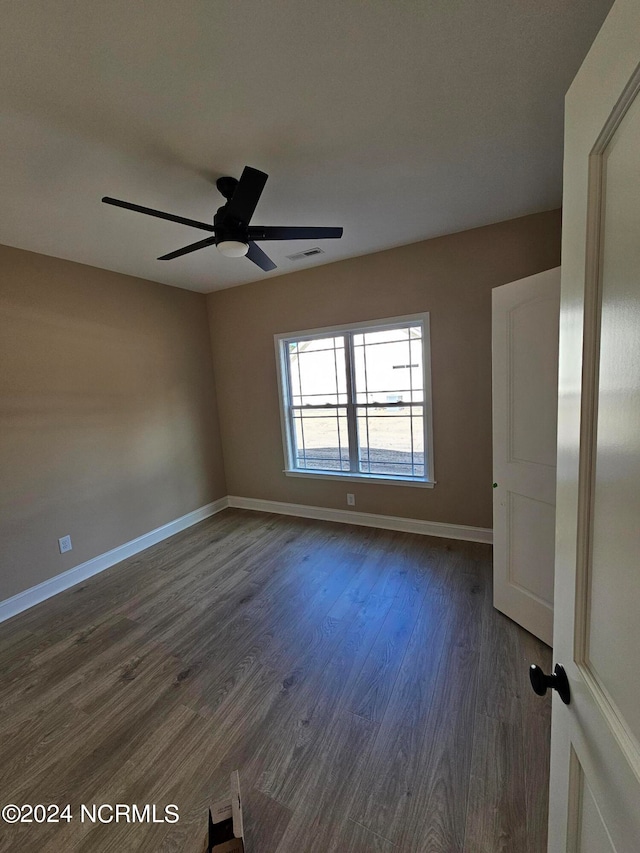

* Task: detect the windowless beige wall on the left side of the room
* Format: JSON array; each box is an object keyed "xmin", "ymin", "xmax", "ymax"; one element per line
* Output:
[{"xmin": 0, "ymin": 247, "xmax": 227, "ymax": 601}]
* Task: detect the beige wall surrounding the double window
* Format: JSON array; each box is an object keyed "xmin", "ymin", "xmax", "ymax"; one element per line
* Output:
[{"xmin": 208, "ymin": 211, "xmax": 560, "ymax": 527}]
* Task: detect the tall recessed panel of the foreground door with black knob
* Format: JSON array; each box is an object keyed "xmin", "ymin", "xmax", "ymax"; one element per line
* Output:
[{"xmin": 583, "ymin": 90, "xmax": 640, "ymax": 748}]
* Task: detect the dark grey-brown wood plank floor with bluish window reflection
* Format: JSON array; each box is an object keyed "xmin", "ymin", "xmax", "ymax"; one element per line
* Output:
[{"xmin": 0, "ymin": 510, "xmax": 551, "ymax": 853}]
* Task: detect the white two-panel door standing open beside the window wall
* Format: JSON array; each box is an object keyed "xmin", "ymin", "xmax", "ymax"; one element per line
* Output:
[{"xmin": 492, "ymin": 267, "xmax": 560, "ymax": 646}]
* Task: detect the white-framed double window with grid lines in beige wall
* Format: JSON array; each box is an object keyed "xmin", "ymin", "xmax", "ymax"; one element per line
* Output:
[{"xmin": 275, "ymin": 314, "xmax": 434, "ymax": 486}]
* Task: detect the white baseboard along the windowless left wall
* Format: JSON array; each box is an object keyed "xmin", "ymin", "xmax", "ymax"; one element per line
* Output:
[{"xmin": 0, "ymin": 497, "xmax": 229, "ymax": 622}]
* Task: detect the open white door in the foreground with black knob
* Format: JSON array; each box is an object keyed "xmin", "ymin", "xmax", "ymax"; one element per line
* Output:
[{"xmin": 549, "ymin": 0, "xmax": 640, "ymax": 853}]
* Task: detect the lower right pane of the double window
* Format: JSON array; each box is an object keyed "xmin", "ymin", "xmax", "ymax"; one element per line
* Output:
[{"xmin": 358, "ymin": 406, "xmax": 424, "ymax": 477}]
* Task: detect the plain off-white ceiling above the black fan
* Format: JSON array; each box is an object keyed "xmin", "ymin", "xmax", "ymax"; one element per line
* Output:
[{"xmin": 0, "ymin": 0, "xmax": 611, "ymax": 292}]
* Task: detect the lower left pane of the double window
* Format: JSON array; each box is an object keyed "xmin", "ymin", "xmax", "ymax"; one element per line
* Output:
[{"xmin": 293, "ymin": 408, "xmax": 349, "ymax": 471}]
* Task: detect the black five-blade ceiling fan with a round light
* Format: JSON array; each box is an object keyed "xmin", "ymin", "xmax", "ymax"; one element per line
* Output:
[{"xmin": 102, "ymin": 166, "xmax": 342, "ymax": 272}]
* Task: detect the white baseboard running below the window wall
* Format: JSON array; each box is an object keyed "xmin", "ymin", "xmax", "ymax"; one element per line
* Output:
[{"xmin": 229, "ymin": 495, "xmax": 493, "ymax": 544}]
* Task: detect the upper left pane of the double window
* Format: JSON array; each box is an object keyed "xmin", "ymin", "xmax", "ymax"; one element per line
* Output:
[{"xmin": 289, "ymin": 337, "xmax": 347, "ymax": 406}]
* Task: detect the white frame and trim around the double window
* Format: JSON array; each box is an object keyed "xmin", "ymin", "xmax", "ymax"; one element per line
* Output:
[{"xmin": 273, "ymin": 312, "xmax": 436, "ymax": 488}]
